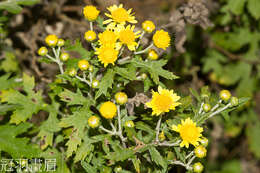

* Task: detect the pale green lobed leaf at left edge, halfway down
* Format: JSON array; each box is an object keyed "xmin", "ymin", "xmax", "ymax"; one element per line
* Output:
[{"xmin": 1, "ymin": 74, "xmax": 44, "ymax": 124}]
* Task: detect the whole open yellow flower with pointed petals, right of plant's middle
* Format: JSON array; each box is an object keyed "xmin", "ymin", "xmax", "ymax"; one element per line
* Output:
[{"xmin": 146, "ymin": 86, "xmax": 181, "ymax": 116}]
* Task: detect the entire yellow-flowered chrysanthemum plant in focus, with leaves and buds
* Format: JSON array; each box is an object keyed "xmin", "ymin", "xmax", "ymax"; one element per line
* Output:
[{"xmin": 1, "ymin": 5, "xmax": 250, "ymax": 173}]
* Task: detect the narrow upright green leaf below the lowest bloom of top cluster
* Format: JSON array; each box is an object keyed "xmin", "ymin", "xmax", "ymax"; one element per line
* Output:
[{"xmin": 95, "ymin": 69, "xmax": 115, "ymax": 99}]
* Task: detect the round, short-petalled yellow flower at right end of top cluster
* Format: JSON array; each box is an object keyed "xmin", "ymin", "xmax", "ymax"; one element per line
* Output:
[{"xmin": 153, "ymin": 30, "xmax": 171, "ymax": 50}]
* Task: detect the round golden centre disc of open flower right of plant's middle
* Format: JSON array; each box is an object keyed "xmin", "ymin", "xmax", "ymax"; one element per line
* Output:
[{"xmin": 154, "ymin": 94, "xmax": 172, "ymax": 112}]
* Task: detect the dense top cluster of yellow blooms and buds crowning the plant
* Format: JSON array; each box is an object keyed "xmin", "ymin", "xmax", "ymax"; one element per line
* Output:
[{"xmin": 83, "ymin": 4, "xmax": 171, "ymax": 67}]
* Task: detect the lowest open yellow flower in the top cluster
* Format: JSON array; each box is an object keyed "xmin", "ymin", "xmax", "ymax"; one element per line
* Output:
[{"xmin": 95, "ymin": 46, "xmax": 118, "ymax": 67}]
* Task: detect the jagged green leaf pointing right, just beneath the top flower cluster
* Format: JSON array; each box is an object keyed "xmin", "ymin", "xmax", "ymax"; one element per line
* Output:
[{"xmin": 131, "ymin": 58, "xmax": 178, "ymax": 85}]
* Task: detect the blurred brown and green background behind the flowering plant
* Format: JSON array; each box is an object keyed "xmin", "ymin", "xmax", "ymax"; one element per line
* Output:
[{"xmin": 0, "ymin": 0, "xmax": 260, "ymax": 173}]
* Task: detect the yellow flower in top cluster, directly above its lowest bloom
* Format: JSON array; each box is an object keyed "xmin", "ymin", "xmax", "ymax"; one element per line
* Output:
[{"xmin": 98, "ymin": 30, "xmax": 117, "ymax": 46}]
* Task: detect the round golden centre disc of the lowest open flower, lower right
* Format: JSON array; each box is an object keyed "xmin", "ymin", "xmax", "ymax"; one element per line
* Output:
[{"xmin": 180, "ymin": 124, "xmax": 200, "ymax": 142}]
